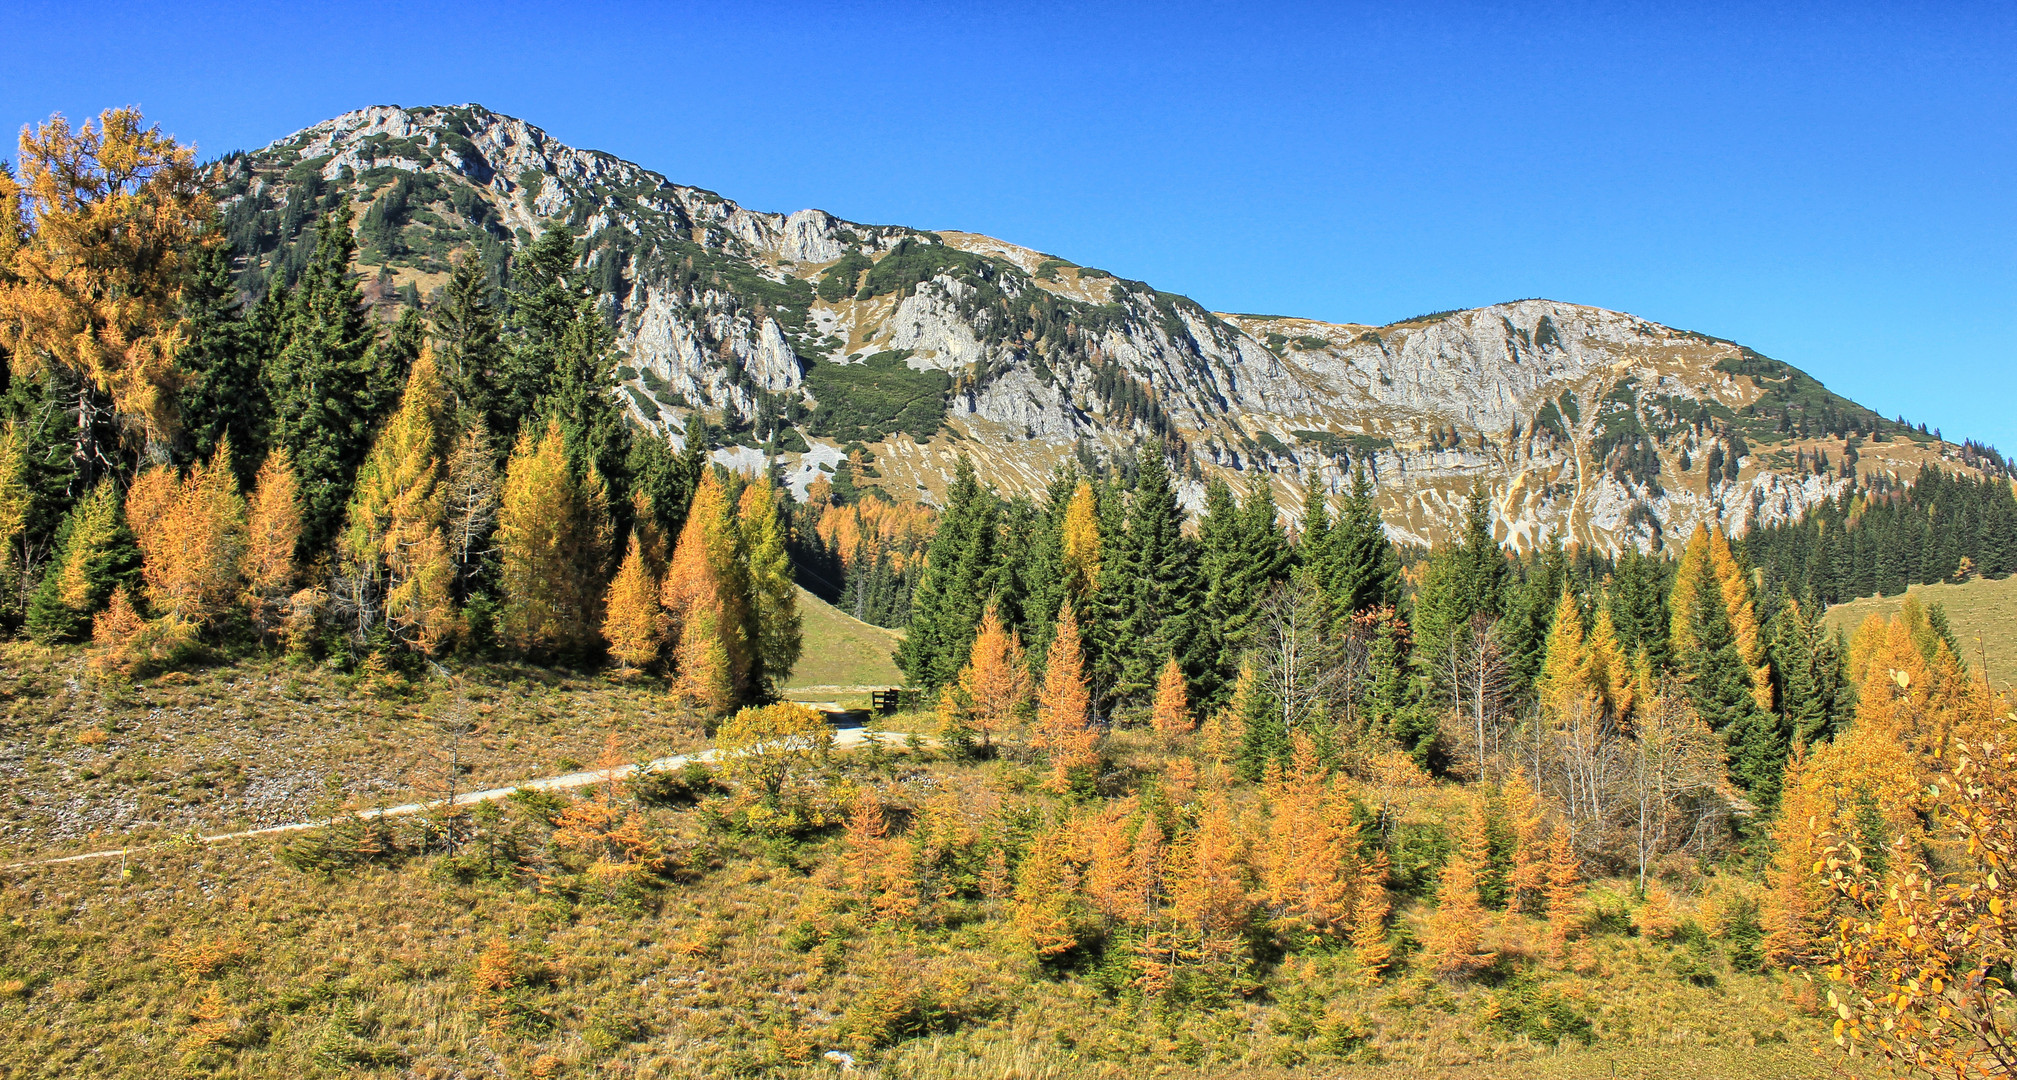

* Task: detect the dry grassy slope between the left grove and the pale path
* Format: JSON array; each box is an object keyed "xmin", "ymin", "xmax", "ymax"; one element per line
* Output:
[{"xmin": 0, "ymin": 642, "xmax": 704, "ymax": 862}]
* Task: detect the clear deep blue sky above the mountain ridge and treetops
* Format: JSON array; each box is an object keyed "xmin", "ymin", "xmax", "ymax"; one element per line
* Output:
[{"xmin": 0, "ymin": 0, "xmax": 2017, "ymax": 452}]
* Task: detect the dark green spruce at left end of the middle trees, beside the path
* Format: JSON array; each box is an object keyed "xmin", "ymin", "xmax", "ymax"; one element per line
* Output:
[{"xmin": 896, "ymin": 454, "xmax": 1000, "ymax": 688}]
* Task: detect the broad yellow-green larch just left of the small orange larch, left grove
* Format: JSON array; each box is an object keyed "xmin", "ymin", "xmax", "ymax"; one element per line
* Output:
[{"xmin": 496, "ymin": 420, "xmax": 609, "ymax": 656}]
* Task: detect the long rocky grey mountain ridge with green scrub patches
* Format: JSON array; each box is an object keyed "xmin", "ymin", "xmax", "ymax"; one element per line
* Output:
[{"xmin": 222, "ymin": 105, "xmax": 2003, "ymax": 549}]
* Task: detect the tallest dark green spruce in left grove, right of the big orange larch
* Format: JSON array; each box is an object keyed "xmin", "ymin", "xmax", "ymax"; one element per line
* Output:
[{"xmin": 264, "ymin": 210, "xmax": 371, "ymax": 551}]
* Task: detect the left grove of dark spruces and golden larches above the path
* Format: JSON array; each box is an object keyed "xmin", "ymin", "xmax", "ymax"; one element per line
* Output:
[{"xmin": 0, "ymin": 109, "xmax": 799, "ymax": 711}]
